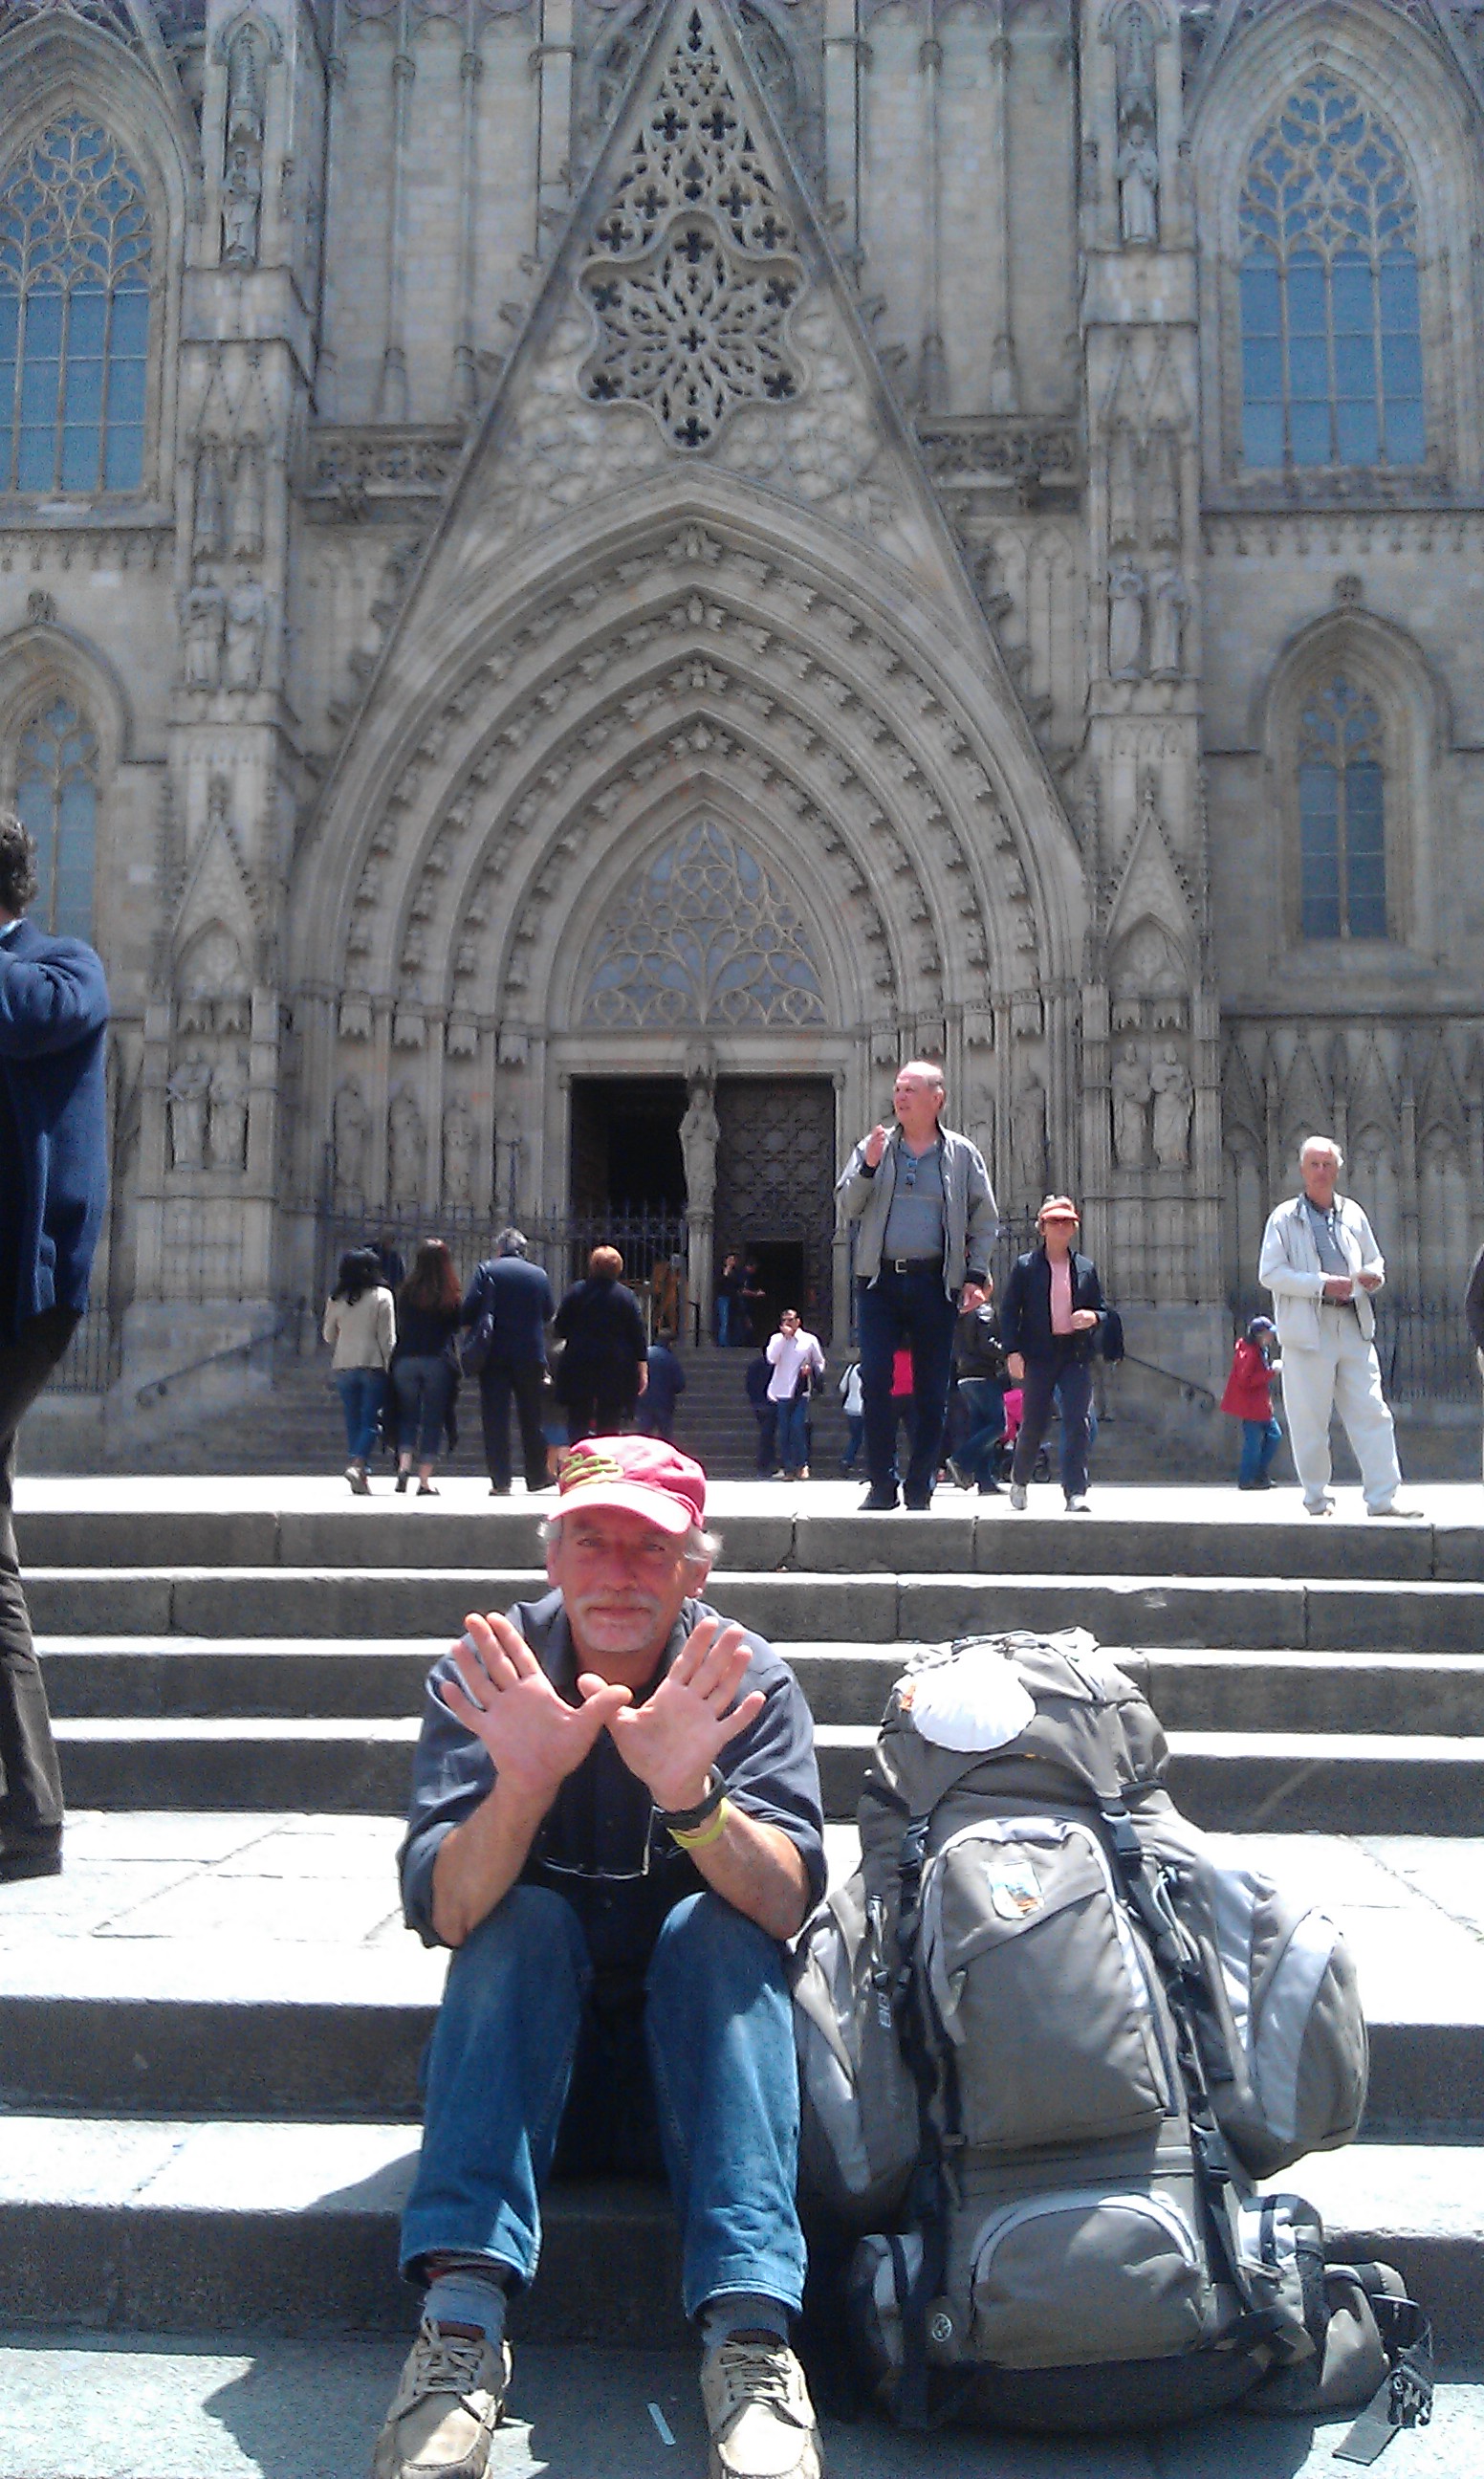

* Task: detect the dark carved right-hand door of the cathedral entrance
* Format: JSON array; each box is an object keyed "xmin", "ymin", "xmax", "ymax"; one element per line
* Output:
[{"xmin": 716, "ymin": 1076, "xmax": 835, "ymax": 1341}]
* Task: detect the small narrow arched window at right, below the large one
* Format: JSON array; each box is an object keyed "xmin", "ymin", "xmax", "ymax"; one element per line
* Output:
[{"xmin": 1298, "ymin": 671, "xmax": 1387, "ymax": 937}]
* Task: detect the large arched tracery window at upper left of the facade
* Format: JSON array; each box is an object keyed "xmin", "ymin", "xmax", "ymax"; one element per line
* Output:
[{"xmin": 0, "ymin": 112, "xmax": 148, "ymax": 491}]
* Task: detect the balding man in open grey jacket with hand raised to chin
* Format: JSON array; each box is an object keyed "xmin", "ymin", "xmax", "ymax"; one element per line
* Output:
[{"xmin": 835, "ymin": 1059, "xmax": 998, "ymax": 1512}]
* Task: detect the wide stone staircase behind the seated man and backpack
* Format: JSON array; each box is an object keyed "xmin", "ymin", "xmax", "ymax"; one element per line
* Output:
[{"xmin": 0, "ymin": 1477, "xmax": 1484, "ymax": 2360}]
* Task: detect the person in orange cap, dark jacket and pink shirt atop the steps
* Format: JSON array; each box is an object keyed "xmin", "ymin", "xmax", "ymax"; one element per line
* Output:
[{"xmin": 1001, "ymin": 1197, "xmax": 1107, "ymax": 1515}]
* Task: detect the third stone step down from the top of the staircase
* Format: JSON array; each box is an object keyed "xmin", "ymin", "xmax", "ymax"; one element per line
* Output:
[{"xmin": 39, "ymin": 1636, "xmax": 1484, "ymax": 1738}]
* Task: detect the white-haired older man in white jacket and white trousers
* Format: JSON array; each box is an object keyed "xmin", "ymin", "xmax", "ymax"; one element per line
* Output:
[{"xmin": 1258, "ymin": 1135, "xmax": 1422, "ymax": 1515}]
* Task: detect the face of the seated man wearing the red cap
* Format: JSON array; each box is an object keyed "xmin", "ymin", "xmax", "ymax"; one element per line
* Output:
[{"xmin": 545, "ymin": 1507, "xmax": 704, "ymax": 1686}]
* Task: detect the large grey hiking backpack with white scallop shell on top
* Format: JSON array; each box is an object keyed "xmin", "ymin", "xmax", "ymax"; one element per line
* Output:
[{"xmin": 796, "ymin": 1632, "xmax": 1420, "ymax": 2427}]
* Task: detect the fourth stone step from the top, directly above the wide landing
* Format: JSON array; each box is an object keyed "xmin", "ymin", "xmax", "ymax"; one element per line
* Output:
[{"xmin": 57, "ymin": 1716, "xmax": 1484, "ymax": 1834}]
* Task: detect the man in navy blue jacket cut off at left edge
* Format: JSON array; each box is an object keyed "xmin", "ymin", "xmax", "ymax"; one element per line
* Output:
[{"xmin": 0, "ymin": 816, "xmax": 109, "ymax": 1884}]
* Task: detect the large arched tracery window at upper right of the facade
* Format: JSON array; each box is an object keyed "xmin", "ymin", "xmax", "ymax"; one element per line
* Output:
[{"xmin": 1238, "ymin": 70, "xmax": 1427, "ymax": 469}]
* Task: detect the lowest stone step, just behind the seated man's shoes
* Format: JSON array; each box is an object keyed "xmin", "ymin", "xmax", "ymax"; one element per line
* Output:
[{"xmin": 0, "ymin": 2115, "xmax": 1484, "ymax": 2360}]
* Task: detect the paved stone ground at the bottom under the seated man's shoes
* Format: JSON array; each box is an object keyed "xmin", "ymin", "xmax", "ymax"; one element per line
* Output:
[{"xmin": 0, "ymin": 2336, "xmax": 1484, "ymax": 2479}]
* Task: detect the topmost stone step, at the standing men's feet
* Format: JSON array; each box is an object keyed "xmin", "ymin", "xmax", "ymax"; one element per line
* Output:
[{"xmin": 17, "ymin": 1480, "xmax": 1484, "ymax": 1584}]
